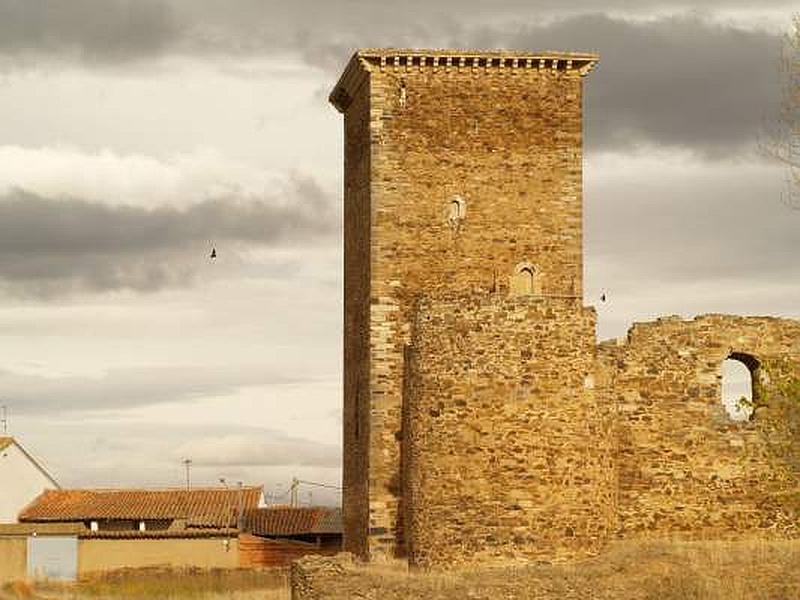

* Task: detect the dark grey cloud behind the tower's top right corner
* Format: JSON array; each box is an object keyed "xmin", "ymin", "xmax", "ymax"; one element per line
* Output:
[{"xmin": 496, "ymin": 15, "xmax": 781, "ymax": 156}]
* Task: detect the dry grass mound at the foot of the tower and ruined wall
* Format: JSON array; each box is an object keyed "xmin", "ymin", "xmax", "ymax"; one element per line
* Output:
[{"xmin": 306, "ymin": 541, "xmax": 800, "ymax": 600}]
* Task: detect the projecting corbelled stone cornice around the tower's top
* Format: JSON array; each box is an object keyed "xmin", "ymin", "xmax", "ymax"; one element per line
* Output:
[{"xmin": 328, "ymin": 48, "xmax": 600, "ymax": 113}]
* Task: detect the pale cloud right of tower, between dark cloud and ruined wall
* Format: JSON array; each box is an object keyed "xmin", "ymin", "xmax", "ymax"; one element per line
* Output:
[{"xmin": 585, "ymin": 158, "xmax": 800, "ymax": 337}]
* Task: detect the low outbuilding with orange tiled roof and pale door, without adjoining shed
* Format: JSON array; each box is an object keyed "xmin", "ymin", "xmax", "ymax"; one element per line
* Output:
[{"xmin": 0, "ymin": 487, "xmax": 263, "ymax": 580}]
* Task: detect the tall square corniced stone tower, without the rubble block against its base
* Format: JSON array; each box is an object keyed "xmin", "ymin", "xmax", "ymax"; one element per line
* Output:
[{"xmin": 330, "ymin": 50, "xmax": 597, "ymax": 557}]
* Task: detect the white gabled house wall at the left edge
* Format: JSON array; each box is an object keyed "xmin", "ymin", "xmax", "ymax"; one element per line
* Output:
[{"xmin": 0, "ymin": 437, "xmax": 60, "ymax": 523}]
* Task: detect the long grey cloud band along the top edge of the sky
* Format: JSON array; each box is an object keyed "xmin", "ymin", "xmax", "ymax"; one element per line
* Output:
[{"xmin": 0, "ymin": 0, "xmax": 794, "ymax": 63}]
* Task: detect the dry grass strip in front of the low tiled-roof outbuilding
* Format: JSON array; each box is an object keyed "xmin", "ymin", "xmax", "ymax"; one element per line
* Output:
[{"xmin": 0, "ymin": 569, "xmax": 291, "ymax": 600}]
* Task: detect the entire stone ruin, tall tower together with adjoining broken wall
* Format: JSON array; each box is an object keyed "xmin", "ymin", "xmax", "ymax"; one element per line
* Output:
[{"xmin": 331, "ymin": 50, "xmax": 800, "ymax": 566}]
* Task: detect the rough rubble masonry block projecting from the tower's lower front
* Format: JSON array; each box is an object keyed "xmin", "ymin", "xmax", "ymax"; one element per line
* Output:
[{"xmin": 406, "ymin": 295, "xmax": 615, "ymax": 567}]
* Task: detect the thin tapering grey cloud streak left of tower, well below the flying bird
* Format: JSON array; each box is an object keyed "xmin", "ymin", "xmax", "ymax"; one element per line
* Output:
[{"xmin": 0, "ymin": 365, "xmax": 308, "ymax": 416}]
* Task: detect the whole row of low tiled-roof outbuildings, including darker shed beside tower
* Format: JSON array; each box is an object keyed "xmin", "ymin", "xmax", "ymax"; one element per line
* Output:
[{"xmin": 0, "ymin": 487, "xmax": 341, "ymax": 582}]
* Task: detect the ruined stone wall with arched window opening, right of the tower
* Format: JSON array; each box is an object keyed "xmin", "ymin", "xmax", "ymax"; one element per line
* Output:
[{"xmin": 598, "ymin": 315, "xmax": 800, "ymax": 539}]
